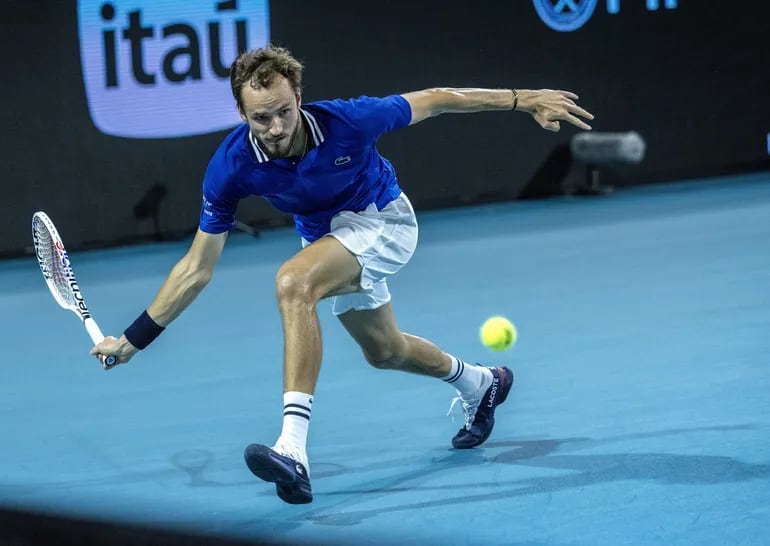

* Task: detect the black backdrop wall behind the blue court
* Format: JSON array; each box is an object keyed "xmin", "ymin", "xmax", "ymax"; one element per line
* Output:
[{"xmin": 0, "ymin": 0, "xmax": 770, "ymax": 255}]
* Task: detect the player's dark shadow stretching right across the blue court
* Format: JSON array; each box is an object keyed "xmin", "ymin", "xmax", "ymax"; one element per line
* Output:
[{"xmin": 305, "ymin": 427, "xmax": 770, "ymax": 525}]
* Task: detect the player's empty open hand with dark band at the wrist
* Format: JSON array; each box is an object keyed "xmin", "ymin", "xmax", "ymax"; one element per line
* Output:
[{"xmin": 516, "ymin": 89, "xmax": 594, "ymax": 131}]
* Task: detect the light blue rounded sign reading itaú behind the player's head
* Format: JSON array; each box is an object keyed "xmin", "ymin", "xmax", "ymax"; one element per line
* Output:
[{"xmin": 78, "ymin": 0, "xmax": 270, "ymax": 138}]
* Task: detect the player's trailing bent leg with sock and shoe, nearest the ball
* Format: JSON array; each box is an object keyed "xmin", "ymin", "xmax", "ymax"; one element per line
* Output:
[{"xmin": 338, "ymin": 303, "xmax": 513, "ymax": 449}]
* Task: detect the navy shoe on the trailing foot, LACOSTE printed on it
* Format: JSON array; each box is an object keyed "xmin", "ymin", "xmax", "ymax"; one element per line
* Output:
[{"xmin": 449, "ymin": 367, "xmax": 513, "ymax": 449}]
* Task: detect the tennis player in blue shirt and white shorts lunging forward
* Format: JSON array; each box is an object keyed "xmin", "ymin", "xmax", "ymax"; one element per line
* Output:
[{"xmin": 91, "ymin": 46, "xmax": 593, "ymax": 504}]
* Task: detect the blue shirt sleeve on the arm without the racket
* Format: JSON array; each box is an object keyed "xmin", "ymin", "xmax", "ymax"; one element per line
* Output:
[{"xmin": 332, "ymin": 95, "xmax": 412, "ymax": 140}]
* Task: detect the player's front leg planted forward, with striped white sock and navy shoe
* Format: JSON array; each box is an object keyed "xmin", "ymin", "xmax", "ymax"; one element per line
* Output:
[{"xmin": 244, "ymin": 237, "xmax": 361, "ymax": 504}]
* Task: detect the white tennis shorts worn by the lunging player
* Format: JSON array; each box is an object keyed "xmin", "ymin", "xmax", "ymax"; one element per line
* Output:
[{"xmin": 302, "ymin": 192, "xmax": 418, "ymax": 315}]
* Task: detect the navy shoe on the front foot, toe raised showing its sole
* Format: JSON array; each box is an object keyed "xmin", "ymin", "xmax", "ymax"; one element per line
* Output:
[{"xmin": 243, "ymin": 444, "xmax": 313, "ymax": 504}]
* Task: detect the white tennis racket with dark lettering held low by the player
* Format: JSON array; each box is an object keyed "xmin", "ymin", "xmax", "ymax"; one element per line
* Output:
[{"xmin": 32, "ymin": 211, "xmax": 117, "ymax": 367}]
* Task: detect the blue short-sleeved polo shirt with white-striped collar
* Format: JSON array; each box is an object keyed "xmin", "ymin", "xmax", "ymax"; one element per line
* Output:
[{"xmin": 200, "ymin": 95, "xmax": 412, "ymax": 242}]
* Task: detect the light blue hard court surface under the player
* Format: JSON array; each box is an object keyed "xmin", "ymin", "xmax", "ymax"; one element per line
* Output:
[{"xmin": 0, "ymin": 173, "xmax": 770, "ymax": 545}]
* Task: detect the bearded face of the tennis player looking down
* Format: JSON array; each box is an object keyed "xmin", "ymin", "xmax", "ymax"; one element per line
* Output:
[{"xmin": 240, "ymin": 76, "xmax": 301, "ymax": 158}]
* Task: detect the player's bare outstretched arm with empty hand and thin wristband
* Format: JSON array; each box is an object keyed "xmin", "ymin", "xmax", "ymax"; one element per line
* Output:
[{"xmin": 402, "ymin": 87, "xmax": 594, "ymax": 131}]
